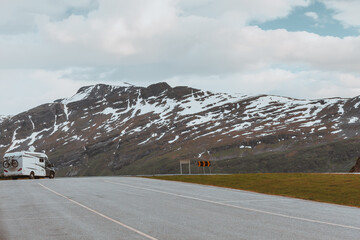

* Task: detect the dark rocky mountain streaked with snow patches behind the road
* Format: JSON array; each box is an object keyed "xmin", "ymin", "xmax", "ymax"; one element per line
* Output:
[{"xmin": 0, "ymin": 83, "xmax": 360, "ymax": 176}]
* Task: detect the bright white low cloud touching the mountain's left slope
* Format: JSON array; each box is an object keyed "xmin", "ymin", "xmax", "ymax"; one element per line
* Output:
[{"xmin": 0, "ymin": 69, "xmax": 92, "ymax": 115}]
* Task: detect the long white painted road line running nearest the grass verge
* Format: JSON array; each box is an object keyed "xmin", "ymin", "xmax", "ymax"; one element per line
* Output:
[{"xmin": 104, "ymin": 180, "xmax": 360, "ymax": 230}]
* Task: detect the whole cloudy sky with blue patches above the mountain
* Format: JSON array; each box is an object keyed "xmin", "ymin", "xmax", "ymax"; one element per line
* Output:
[{"xmin": 0, "ymin": 0, "xmax": 360, "ymax": 115}]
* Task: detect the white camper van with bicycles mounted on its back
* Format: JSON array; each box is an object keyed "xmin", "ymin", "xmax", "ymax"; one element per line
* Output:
[{"xmin": 3, "ymin": 152, "xmax": 55, "ymax": 179}]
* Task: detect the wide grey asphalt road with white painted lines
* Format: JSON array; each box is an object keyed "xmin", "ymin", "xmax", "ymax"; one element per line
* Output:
[{"xmin": 0, "ymin": 177, "xmax": 360, "ymax": 240}]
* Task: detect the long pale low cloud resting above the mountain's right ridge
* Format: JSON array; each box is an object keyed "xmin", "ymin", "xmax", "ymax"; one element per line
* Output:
[{"xmin": 166, "ymin": 68, "xmax": 360, "ymax": 99}]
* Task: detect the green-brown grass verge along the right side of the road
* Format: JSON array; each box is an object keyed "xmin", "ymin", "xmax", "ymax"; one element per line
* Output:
[{"xmin": 151, "ymin": 173, "xmax": 360, "ymax": 207}]
